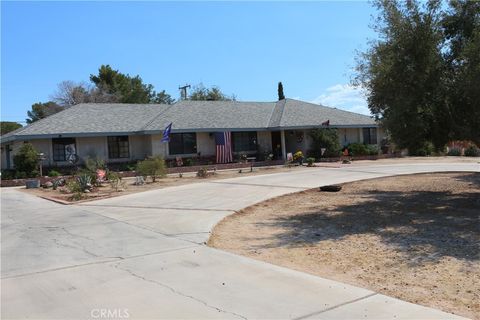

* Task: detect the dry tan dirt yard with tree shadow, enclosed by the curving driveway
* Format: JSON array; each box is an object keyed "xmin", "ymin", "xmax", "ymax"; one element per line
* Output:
[{"xmin": 209, "ymin": 173, "xmax": 480, "ymax": 319}]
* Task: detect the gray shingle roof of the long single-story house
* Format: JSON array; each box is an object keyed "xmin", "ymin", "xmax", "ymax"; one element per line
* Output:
[{"xmin": 1, "ymin": 99, "xmax": 376, "ymax": 142}]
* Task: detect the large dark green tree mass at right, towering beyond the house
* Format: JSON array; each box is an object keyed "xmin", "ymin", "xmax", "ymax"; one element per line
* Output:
[{"xmin": 353, "ymin": 0, "xmax": 480, "ymax": 153}]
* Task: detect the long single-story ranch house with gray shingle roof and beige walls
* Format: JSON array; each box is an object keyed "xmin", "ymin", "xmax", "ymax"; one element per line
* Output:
[{"xmin": 1, "ymin": 99, "xmax": 383, "ymax": 169}]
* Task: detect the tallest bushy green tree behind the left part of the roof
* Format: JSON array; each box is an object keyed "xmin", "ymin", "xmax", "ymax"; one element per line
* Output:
[{"xmin": 90, "ymin": 65, "xmax": 174, "ymax": 104}]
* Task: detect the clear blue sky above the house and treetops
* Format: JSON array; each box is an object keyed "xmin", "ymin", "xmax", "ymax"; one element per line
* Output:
[{"xmin": 1, "ymin": 1, "xmax": 375, "ymax": 121}]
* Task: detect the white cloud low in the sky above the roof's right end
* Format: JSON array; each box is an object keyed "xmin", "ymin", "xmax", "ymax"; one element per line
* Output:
[{"xmin": 312, "ymin": 84, "xmax": 370, "ymax": 115}]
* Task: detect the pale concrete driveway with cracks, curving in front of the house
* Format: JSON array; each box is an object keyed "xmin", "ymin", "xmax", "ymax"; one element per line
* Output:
[{"xmin": 1, "ymin": 160, "xmax": 480, "ymax": 319}]
